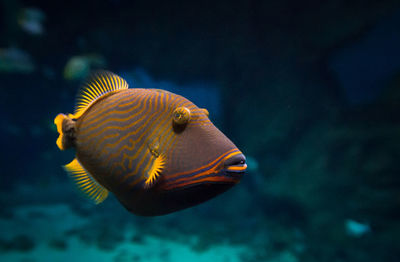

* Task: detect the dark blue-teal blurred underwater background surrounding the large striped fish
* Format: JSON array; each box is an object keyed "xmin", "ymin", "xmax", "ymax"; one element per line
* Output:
[{"xmin": 0, "ymin": 0, "xmax": 400, "ymax": 262}]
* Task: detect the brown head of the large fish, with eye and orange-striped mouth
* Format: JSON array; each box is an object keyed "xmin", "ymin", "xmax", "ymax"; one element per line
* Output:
[{"xmin": 157, "ymin": 98, "xmax": 247, "ymax": 192}]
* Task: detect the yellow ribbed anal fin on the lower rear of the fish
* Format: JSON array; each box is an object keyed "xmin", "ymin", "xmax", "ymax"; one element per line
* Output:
[{"xmin": 64, "ymin": 158, "xmax": 108, "ymax": 204}]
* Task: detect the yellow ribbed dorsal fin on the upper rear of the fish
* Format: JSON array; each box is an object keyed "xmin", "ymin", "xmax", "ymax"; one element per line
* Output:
[{"xmin": 68, "ymin": 71, "xmax": 128, "ymax": 119}]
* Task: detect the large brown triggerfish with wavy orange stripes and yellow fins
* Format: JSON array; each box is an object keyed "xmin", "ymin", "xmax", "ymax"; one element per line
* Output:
[{"xmin": 54, "ymin": 71, "xmax": 247, "ymax": 216}]
